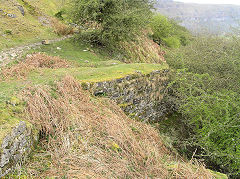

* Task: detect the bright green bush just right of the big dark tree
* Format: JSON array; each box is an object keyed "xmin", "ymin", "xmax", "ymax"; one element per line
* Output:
[{"xmin": 150, "ymin": 14, "xmax": 191, "ymax": 48}]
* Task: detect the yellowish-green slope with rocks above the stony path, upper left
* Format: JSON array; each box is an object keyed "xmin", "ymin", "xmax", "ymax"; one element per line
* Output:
[{"xmin": 0, "ymin": 0, "xmax": 61, "ymax": 50}]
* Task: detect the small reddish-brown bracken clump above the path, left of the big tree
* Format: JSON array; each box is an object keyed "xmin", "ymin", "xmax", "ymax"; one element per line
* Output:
[{"xmin": 51, "ymin": 18, "xmax": 74, "ymax": 35}]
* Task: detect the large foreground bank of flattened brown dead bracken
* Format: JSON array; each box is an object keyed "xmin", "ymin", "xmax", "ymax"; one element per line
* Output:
[{"xmin": 19, "ymin": 76, "xmax": 211, "ymax": 178}]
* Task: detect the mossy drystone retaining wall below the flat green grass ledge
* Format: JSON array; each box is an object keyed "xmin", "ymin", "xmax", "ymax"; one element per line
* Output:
[{"xmin": 83, "ymin": 70, "xmax": 169, "ymax": 122}]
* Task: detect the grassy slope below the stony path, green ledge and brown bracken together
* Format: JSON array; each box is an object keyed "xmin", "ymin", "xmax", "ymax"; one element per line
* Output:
[{"xmin": 0, "ymin": 34, "xmax": 229, "ymax": 178}]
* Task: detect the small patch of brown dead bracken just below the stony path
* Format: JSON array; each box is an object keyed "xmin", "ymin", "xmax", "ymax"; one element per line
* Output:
[{"xmin": 1, "ymin": 53, "xmax": 71, "ymax": 79}]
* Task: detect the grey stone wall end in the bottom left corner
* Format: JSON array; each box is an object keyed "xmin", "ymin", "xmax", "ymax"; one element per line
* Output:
[{"xmin": 0, "ymin": 121, "xmax": 37, "ymax": 178}]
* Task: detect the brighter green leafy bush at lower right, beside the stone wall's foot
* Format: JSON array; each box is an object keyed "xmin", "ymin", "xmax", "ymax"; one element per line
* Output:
[{"xmin": 171, "ymin": 70, "xmax": 240, "ymax": 176}]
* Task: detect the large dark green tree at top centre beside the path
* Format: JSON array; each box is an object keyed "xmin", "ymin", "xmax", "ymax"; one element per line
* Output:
[{"xmin": 70, "ymin": 0, "xmax": 152, "ymax": 45}]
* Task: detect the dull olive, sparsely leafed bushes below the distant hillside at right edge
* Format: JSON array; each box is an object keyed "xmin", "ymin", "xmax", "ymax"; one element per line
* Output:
[{"xmin": 166, "ymin": 37, "xmax": 240, "ymax": 92}]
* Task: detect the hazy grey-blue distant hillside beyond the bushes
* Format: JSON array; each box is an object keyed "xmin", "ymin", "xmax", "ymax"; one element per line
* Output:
[{"xmin": 156, "ymin": 0, "xmax": 240, "ymax": 34}]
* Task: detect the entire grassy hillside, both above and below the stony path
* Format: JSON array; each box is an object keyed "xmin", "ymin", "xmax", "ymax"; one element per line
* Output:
[{"xmin": 0, "ymin": 0, "xmax": 230, "ymax": 178}]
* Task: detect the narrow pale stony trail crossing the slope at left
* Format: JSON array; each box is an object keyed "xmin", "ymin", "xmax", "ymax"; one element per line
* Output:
[{"xmin": 0, "ymin": 35, "xmax": 72, "ymax": 67}]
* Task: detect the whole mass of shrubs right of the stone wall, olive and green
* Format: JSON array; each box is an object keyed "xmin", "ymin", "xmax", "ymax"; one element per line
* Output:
[{"xmin": 167, "ymin": 37, "xmax": 240, "ymax": 177}]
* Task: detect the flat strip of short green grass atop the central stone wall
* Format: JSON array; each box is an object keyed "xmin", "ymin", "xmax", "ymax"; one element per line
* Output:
[{"xmin": 29, "ymin": 63, "xmax": 168, "ymax": 83}]
